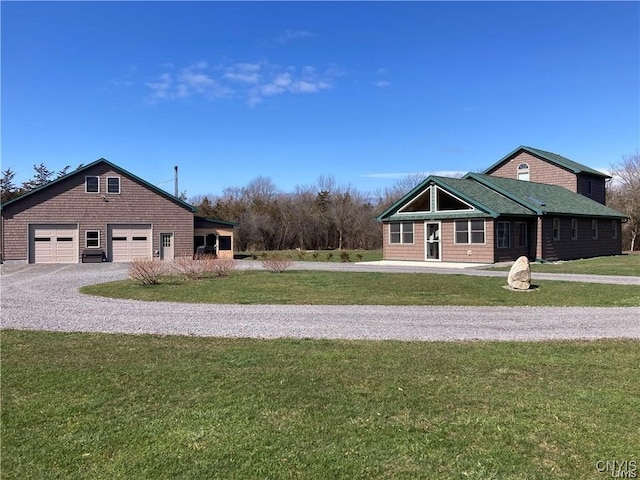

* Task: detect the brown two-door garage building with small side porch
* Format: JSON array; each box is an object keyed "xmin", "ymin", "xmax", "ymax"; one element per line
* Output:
[{"xmin": 0, "ymin": 158, "xmax": 235, "ymax": 263}]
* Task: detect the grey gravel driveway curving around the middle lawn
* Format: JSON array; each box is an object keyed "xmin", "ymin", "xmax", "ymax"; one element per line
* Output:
[{"xmin": 0, "ymin": 262, "xmax": 640, "ymax": 341}]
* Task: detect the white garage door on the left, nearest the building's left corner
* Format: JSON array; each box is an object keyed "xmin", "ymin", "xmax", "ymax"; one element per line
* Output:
[{"xmin": 29, "ymin": 224, "xmax": 78, "ymax": 263}]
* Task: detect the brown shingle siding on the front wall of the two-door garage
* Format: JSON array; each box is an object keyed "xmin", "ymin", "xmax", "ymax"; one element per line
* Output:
[{"xmin": 2, "ymin": 163, "xmax": 193, "ymax": 261}]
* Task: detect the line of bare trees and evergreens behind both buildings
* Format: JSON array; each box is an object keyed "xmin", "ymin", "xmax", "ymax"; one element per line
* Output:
[{"xmin": 0, "ymin": 152, "xmax": 640, "ymax": 251}]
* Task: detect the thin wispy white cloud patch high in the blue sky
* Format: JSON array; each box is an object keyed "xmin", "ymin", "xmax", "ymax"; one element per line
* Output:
[{"xmin": 146, "ymin": 61, "xmax": 344, "ymax": 106}]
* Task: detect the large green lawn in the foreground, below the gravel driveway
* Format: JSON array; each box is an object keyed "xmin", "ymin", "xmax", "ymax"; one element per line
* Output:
[{"xmin": 1, "ymin": 330, "xmax": 640, "ymax": 480}]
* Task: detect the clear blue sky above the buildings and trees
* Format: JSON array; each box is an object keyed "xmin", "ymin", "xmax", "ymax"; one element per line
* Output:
[{"xmin": 0, "ymin": 1, "xmax": 640, "ymax": 197}]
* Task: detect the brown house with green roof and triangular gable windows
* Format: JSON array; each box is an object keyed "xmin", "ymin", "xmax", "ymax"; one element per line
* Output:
[{"xmin": 377, "ymin": 147, "xmax": 625, "ymax": 263}]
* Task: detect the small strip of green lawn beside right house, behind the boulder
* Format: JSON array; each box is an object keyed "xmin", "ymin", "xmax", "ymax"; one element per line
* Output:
[{"xmin": 494, "ymin": 252, "xmax": 640, "ymax": 277}]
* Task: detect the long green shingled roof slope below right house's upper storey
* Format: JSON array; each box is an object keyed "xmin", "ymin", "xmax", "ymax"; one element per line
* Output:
[{"xmin": 464, "ymin": 173, "xmax": 626, "ymax": 218}]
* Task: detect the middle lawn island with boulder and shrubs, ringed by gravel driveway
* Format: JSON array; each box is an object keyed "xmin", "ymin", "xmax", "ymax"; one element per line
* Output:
[{"xmin": 80, "ymin": 270, "xmax": 640, "ymax": 307}]
